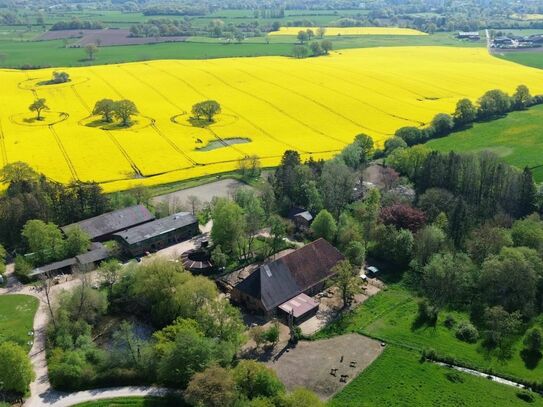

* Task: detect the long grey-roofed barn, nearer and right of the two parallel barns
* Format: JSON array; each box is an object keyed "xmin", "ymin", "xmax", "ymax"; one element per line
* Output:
[{"xmin": 113, "ymin": 212, "xmax": 199, "ymax": 256}]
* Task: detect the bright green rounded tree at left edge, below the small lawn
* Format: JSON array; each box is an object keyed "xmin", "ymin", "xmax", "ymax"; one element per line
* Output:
[{"xmin": 0, "ymin": 342, "xmax": 35, "ymax": 394}]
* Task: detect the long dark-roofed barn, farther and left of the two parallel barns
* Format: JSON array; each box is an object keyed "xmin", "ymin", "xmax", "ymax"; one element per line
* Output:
[{"xmin": 61, "ymin": 205, "xmax": 155, "ymax": 242}]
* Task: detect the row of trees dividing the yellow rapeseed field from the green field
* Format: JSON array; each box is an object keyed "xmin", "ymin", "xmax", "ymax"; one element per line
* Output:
[{"xmin": 389, "ymin": 85, "xmax": 543, "ymax": 146}]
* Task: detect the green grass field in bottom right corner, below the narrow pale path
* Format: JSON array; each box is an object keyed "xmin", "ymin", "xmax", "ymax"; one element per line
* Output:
[{"xmin": 328, "ymin": 345, "xmax": 543, "ymax": 407}]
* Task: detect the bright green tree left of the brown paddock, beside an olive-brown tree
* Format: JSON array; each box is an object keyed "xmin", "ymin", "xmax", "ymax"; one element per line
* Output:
[{"xmin": 233, "ymin": 360, "xmax": 285, "ymax": 400}]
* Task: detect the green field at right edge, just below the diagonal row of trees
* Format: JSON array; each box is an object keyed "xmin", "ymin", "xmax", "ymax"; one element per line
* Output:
[{"xmin": 426, "ymin": 105, "xmax": 543, "ymax": 182}]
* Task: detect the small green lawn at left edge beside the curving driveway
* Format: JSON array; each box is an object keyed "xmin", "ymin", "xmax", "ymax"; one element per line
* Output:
[{"xmin": 0, "ymin": 294, "xmax": 38, "ymax": 349}]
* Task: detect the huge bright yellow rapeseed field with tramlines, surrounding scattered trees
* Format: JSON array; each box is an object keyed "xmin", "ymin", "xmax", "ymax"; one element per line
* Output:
[{"xmin": 0, "ymin": 47, "xmax": 543, "ymax": 191}]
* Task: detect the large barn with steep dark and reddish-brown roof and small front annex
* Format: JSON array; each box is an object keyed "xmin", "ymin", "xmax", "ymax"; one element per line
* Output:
[{"xmin": 231, "ymin": 239, "xmax": 344, "ymax": 322}]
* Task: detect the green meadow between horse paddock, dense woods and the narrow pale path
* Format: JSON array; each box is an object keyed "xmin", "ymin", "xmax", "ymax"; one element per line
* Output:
[{"xmin": 317, "ymin": 285, "xmax": 543, "ymax": 381}]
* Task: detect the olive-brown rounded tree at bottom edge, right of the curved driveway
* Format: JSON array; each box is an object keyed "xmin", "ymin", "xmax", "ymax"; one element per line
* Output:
[{"xmin": 184, "ymin": 366, "xmax": 237, "ymax": 407}]
